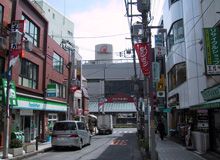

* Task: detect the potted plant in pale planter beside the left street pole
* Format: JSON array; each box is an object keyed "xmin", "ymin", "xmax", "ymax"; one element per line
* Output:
[{"xmin": 8, "ymin": 139, "xmax": 23, "ymax": 157}]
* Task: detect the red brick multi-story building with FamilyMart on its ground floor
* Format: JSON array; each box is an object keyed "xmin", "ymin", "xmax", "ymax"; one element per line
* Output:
[{"xmin": 0, "ymin": 0, "xmax": 75, "ymax": 145}]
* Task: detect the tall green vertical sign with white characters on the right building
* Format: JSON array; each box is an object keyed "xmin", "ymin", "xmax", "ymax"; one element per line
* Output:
[{"xmin": 204, "ymin": 27, "xmax": 220, "ymax": 75}]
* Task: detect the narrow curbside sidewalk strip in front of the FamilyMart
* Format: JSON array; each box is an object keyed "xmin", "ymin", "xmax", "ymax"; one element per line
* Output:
[{"xmin": 0, "ymin": 142, "xmax": 52, "ymax": 160}]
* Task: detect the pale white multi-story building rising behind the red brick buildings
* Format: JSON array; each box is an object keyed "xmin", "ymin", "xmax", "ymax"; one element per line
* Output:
[{"xmin": 31, "ymin": 0, "xmax": 85, "ymax": 119}]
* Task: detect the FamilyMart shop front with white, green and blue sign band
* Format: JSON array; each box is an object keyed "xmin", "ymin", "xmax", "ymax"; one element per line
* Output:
[{"xmin": 11, "ymin": 96, "xmax": 67, "ymax": 142}]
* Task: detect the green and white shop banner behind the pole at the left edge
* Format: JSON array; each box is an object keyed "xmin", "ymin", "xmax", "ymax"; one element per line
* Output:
[{"xmin": 0, "ymin": 78, "xmax": 18, "ymax": 106}]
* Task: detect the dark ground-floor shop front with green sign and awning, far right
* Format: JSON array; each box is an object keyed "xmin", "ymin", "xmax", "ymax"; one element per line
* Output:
[{"xmin": 190, "ymin": 85, "xmax": 220, "ymax": 154}]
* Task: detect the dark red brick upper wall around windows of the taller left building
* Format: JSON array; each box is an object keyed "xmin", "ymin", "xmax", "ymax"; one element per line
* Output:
[{"xmin": 12, "ymin": 0, "xmax": 48, "ymax": 96}]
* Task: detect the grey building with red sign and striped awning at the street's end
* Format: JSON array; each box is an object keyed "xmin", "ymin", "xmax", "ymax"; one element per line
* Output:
[{"xmin": 83, "ymin": 60, "xmax": 143, "ymax": 125}]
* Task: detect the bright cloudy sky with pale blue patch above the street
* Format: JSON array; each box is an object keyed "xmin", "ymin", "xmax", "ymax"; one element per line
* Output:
[{"xmin": 46, "ymin": 0, "xmax": 131, "ymax": 60}]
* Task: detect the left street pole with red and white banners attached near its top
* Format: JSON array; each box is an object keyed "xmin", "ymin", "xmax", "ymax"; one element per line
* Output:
[{"xmin": 2, "ymin": 20, "xmax": 24, "ymax": 159}]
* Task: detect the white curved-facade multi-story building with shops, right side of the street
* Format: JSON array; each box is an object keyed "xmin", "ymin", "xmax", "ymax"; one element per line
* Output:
[{"xmin": 163, "ymin": 0, "xmax": 220, "ymax": 152}]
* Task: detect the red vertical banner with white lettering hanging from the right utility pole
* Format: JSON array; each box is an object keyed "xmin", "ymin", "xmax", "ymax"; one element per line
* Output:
[{"xmin": 134, "ymin": 43, "xmax": 151, "ymax": 76}]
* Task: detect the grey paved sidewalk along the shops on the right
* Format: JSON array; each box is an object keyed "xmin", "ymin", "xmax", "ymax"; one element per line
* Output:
[{"xmin": 155, "ymin": 135, "xmax": 207, "ymax": 160}]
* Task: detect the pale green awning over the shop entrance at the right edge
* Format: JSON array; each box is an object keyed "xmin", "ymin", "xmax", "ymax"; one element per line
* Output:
[{"xmin": 190, "ymin": 99, "xmax": 220, "ymax": 110}]
